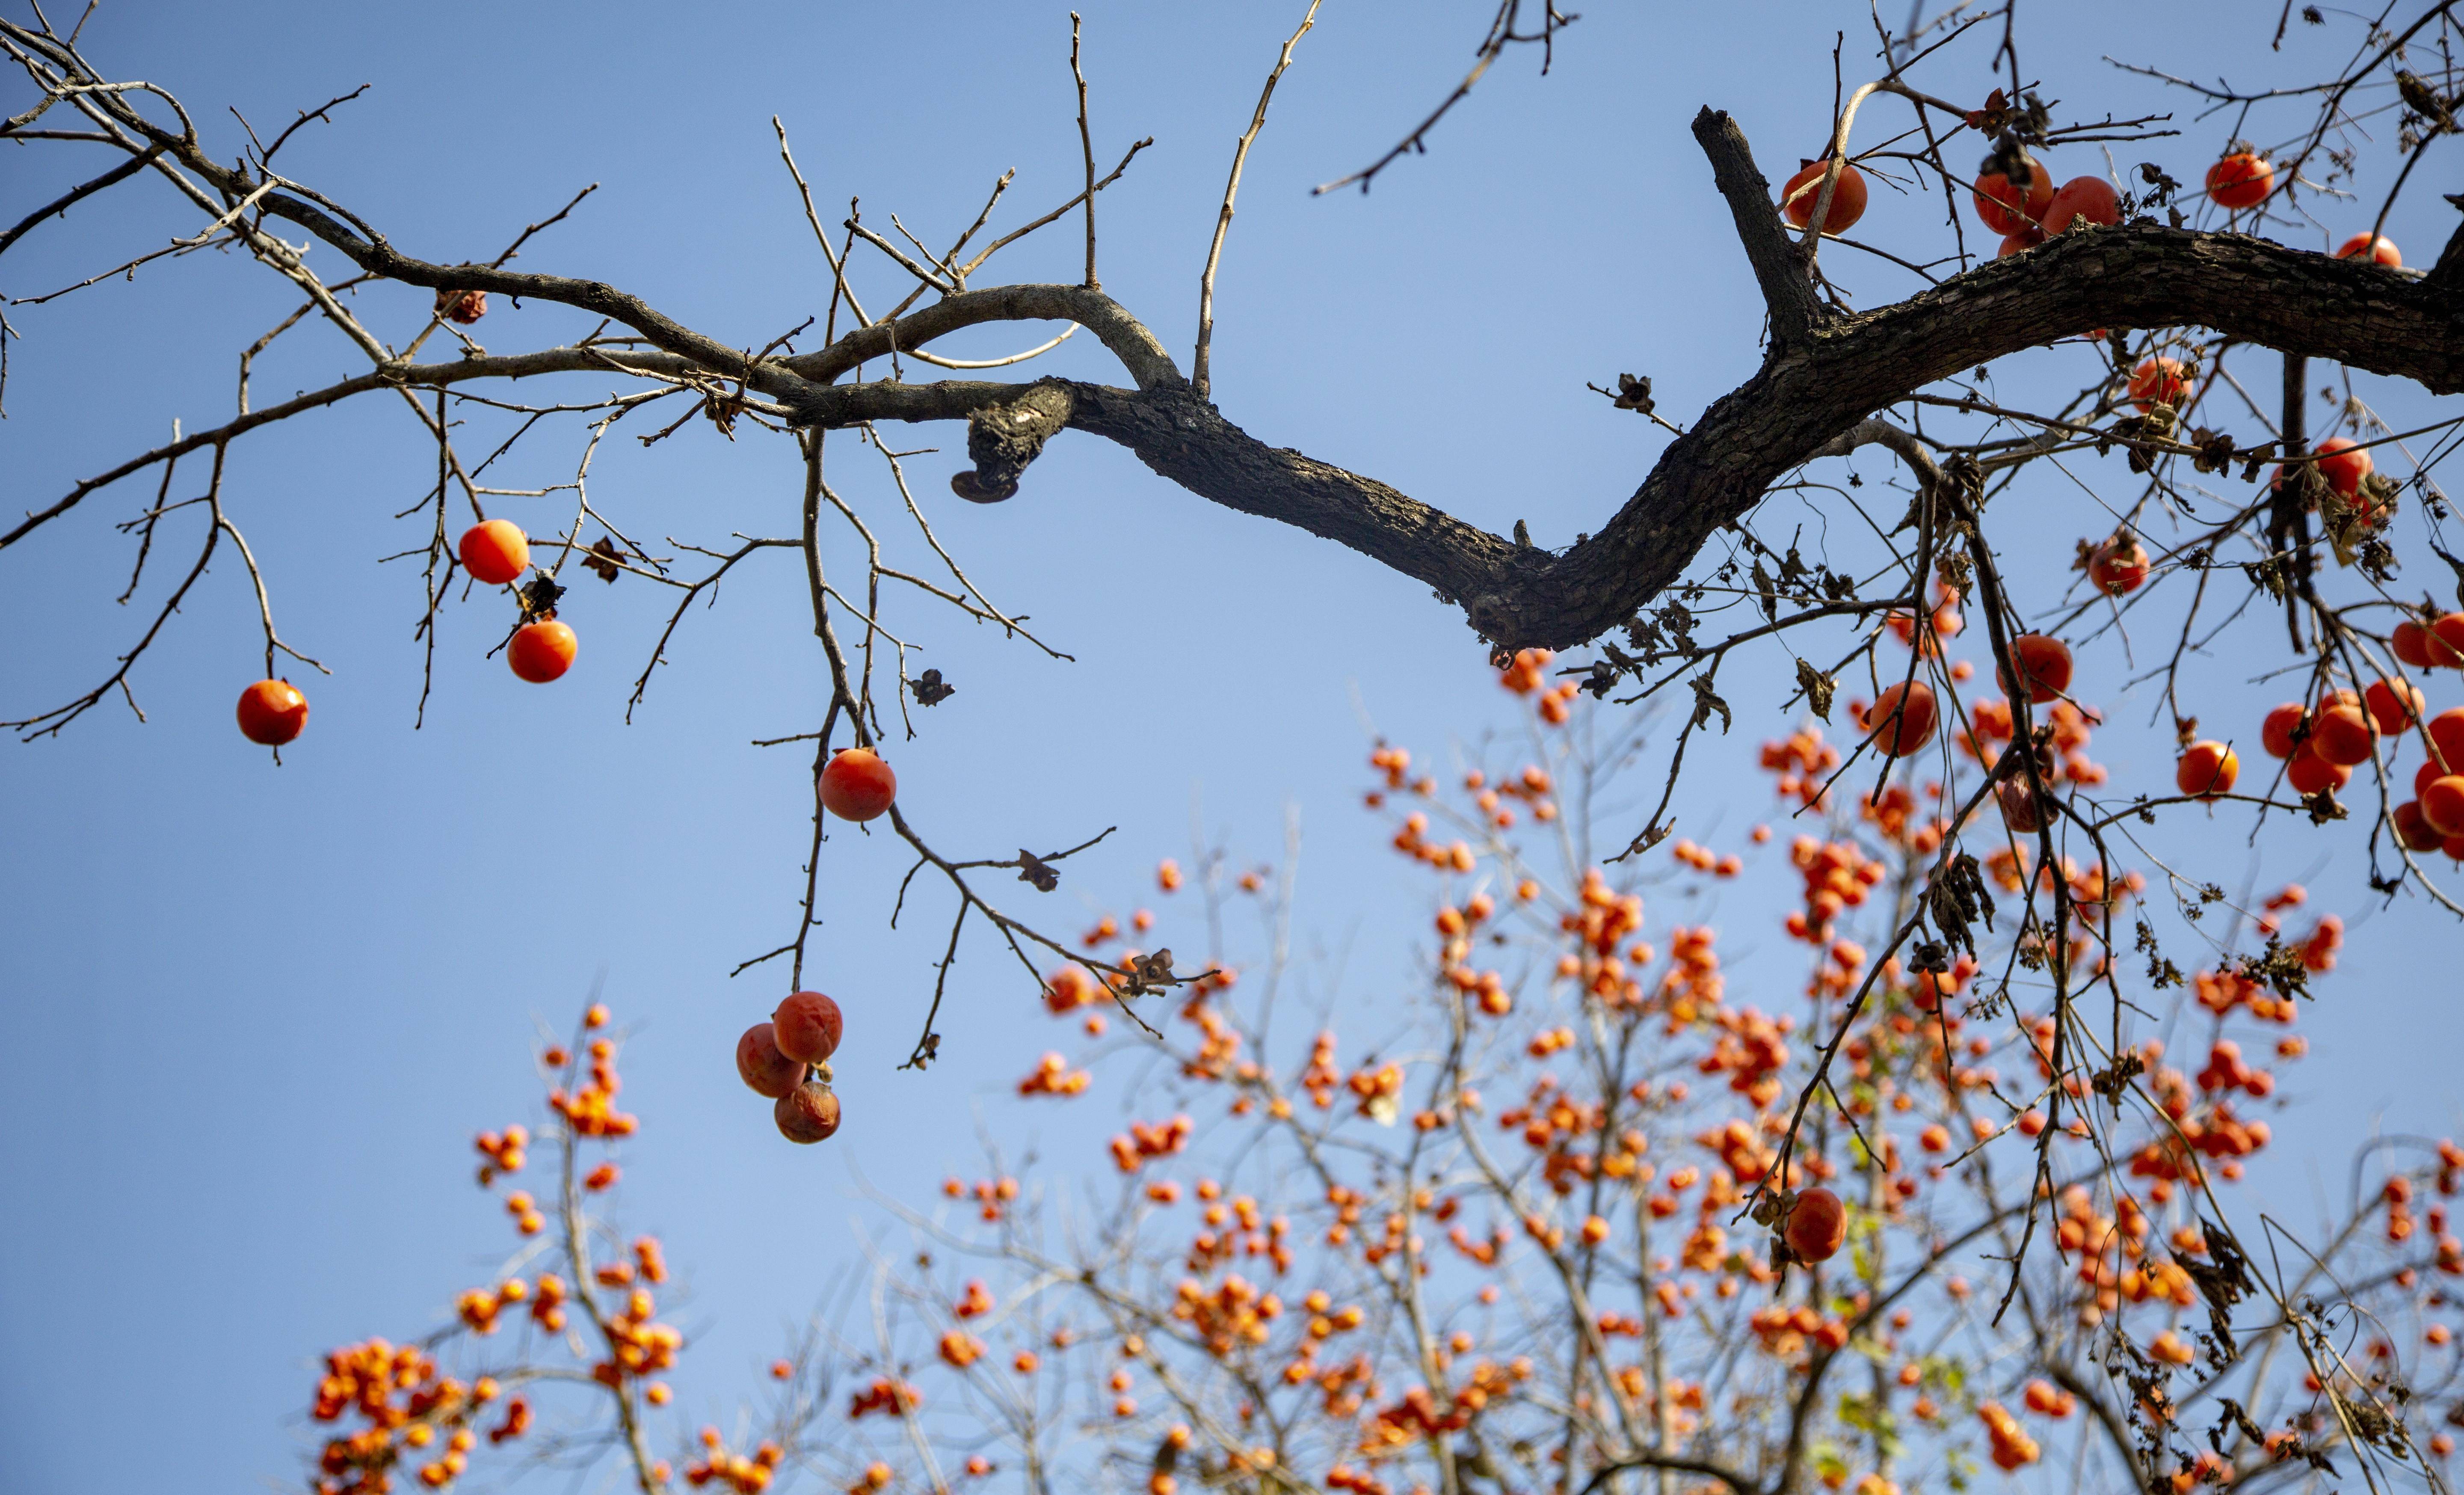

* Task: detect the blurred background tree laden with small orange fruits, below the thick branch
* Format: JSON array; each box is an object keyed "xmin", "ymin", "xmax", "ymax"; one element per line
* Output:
[{"xmin": 311, "ymin": 675, "xmax": 2464, "ymax": 1495}]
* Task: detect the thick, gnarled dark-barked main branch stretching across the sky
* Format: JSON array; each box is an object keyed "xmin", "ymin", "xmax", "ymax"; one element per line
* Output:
[{"xmin": 72, "ymin": 92, "xmax": 2464, "ymax": 648}]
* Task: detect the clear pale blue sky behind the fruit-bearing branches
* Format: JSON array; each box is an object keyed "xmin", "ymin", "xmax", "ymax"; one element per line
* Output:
[{"xmin": 0, "ymin": 0, "xmax": 2464, "ymax": 1495}]
